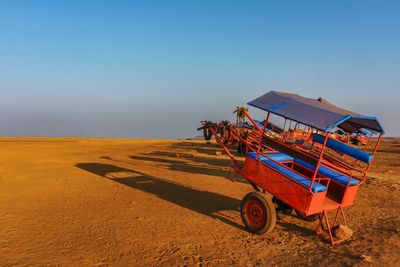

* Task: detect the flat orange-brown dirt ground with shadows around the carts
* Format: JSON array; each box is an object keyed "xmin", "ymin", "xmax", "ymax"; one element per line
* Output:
[{"xmin": 0, "ymin": 138, "xmax": 400, "ymax": 266}]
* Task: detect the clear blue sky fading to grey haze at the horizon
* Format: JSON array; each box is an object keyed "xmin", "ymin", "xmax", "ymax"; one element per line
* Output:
[{"xmin": 0, "ymin": 0, "xmax": 400, "ymax": 138}]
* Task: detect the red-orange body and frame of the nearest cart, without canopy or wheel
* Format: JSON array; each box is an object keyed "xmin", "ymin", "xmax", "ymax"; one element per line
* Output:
[{"xmin": 202, "ymin": 103, "xmax": 382, "ymax": 244}]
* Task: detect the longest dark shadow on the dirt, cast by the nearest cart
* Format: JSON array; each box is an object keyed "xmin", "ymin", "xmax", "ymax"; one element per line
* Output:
[{"xmin": 75, "ymin": 163, "xmax": 244, "ymax": 230}]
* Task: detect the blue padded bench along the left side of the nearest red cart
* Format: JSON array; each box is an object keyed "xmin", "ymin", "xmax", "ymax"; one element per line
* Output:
[{"xmin": 247, "ymin": 152, "xmax": 327, "ymax": 193}]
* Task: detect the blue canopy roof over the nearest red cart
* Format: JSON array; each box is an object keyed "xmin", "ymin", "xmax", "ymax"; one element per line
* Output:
[{"xmin": 247, "ymin": 91, "xmax": 384, "ymax": 133}]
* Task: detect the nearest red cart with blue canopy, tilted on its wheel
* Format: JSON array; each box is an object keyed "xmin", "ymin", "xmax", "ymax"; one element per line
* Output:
[{"xmin": 201, "ymin": 91, "xmax": 384, "ymax": 244}]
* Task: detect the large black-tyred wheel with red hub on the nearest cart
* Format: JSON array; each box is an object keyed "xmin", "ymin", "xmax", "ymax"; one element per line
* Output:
[{"xmin": 240, "ymin": 192, "xmax": 276, "ymax": 234}]
